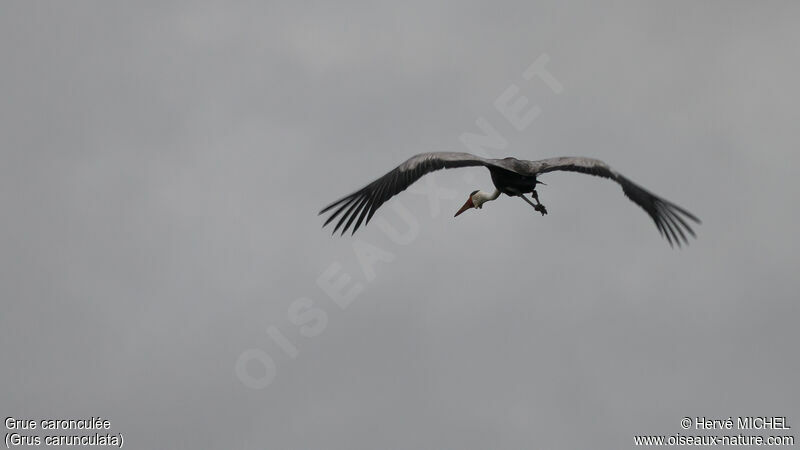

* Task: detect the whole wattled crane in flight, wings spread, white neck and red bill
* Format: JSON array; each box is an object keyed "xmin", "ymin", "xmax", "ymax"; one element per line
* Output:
[{"xmin": 319, "ymin": 152, "xmax": 700, "ymax": 246}]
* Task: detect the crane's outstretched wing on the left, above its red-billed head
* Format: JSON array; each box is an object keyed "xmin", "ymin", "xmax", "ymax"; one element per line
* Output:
[{"xmin": 319, "ymin": 152, "xmax": 490, "ymax": 234}]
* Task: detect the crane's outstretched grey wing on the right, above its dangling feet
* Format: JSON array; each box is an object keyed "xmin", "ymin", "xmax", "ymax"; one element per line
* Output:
[{"xmin": 520, "ymin": 157, "xmax": 700, "ymax": 246}]
